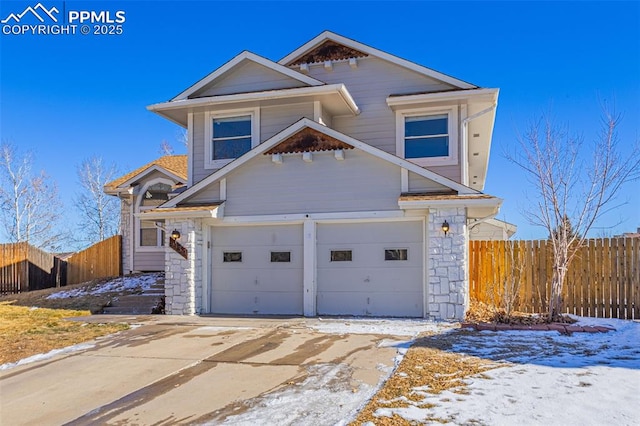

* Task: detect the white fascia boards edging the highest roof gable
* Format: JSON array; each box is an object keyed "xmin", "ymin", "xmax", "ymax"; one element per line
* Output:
[{"xmin": 278, "ymin": 31, "xmax": 478, "ymax": 89}]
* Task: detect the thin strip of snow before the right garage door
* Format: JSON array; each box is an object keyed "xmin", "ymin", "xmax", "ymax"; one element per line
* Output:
[{"xmin": 308, "ymin": 318, "xmax": 460, "ymax": 337}]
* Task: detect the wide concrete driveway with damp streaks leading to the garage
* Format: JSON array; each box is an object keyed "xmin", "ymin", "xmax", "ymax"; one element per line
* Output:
[{"xmin": 0, "ymin": 316, "xmax": 419, "ymax": 425}]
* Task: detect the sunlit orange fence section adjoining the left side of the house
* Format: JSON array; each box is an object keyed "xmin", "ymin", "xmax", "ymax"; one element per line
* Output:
[{"xmin": 67, "ymin": 235, "xmax": 122, "ymax": 285}]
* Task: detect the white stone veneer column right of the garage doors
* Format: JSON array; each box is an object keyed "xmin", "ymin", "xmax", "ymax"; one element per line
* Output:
[{"xmin": 427, "ymin": 208, "xmax": 469, "ymax": 321}]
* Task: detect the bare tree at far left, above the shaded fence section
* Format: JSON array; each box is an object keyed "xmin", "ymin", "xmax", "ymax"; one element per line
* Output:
[{"xmin": 0, "ymin": 143, "xmax": 66, "ymax": 251}]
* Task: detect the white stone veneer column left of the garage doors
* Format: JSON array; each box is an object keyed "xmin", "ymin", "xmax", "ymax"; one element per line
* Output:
[{"xmin": 164, "ymin": 219, "xmax": 204, "ymax": 315}]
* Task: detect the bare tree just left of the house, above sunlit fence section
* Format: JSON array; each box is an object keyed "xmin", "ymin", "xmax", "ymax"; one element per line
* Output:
[{"xmin": 75, "ymin": 157, "xmax": 120, "ymax": 244}]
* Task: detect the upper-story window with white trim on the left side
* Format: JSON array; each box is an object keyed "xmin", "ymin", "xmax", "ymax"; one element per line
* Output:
[{"xmin": 205, "ymin": 108, "xmax": 260, "ymax": 169}]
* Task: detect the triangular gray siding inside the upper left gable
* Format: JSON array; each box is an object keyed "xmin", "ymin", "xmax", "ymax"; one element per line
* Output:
[{"xmin": 191, "ymin": 60, "xmax": 308, "ymax": 98}]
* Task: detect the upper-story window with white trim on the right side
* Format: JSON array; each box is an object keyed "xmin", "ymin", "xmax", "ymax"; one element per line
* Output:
[{"xmin": 396, "ymin": 108, "xmax": 458, "ymax": 166}]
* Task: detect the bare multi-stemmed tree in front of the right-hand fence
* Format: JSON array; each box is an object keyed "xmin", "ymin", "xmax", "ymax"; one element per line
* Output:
[{"xmin": 507, "ymin": 109, "xmax": 640, "ymax": 320}]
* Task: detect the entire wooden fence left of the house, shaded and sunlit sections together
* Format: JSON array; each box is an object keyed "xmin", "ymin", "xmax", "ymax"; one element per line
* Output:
[{"xmin": 0, "ymin": 235, "xmax": 122, "ymax": 294}]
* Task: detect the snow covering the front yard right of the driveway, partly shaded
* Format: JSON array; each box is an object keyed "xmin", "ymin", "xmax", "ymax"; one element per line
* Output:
[{"xmin": 376, "ymin": 318, "xmax": 640, "ymax": 425}]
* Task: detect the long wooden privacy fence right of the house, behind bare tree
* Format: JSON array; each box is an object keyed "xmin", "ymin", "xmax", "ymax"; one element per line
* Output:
[{"xmin": 469, "ymin": 238, "xmax": 640, "ymax": 319}]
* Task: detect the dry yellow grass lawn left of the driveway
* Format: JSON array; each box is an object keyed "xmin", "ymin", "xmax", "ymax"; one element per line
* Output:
[{"xmin": 0, "ymin": 302, "xmax": 129, "ymax": 364}]
